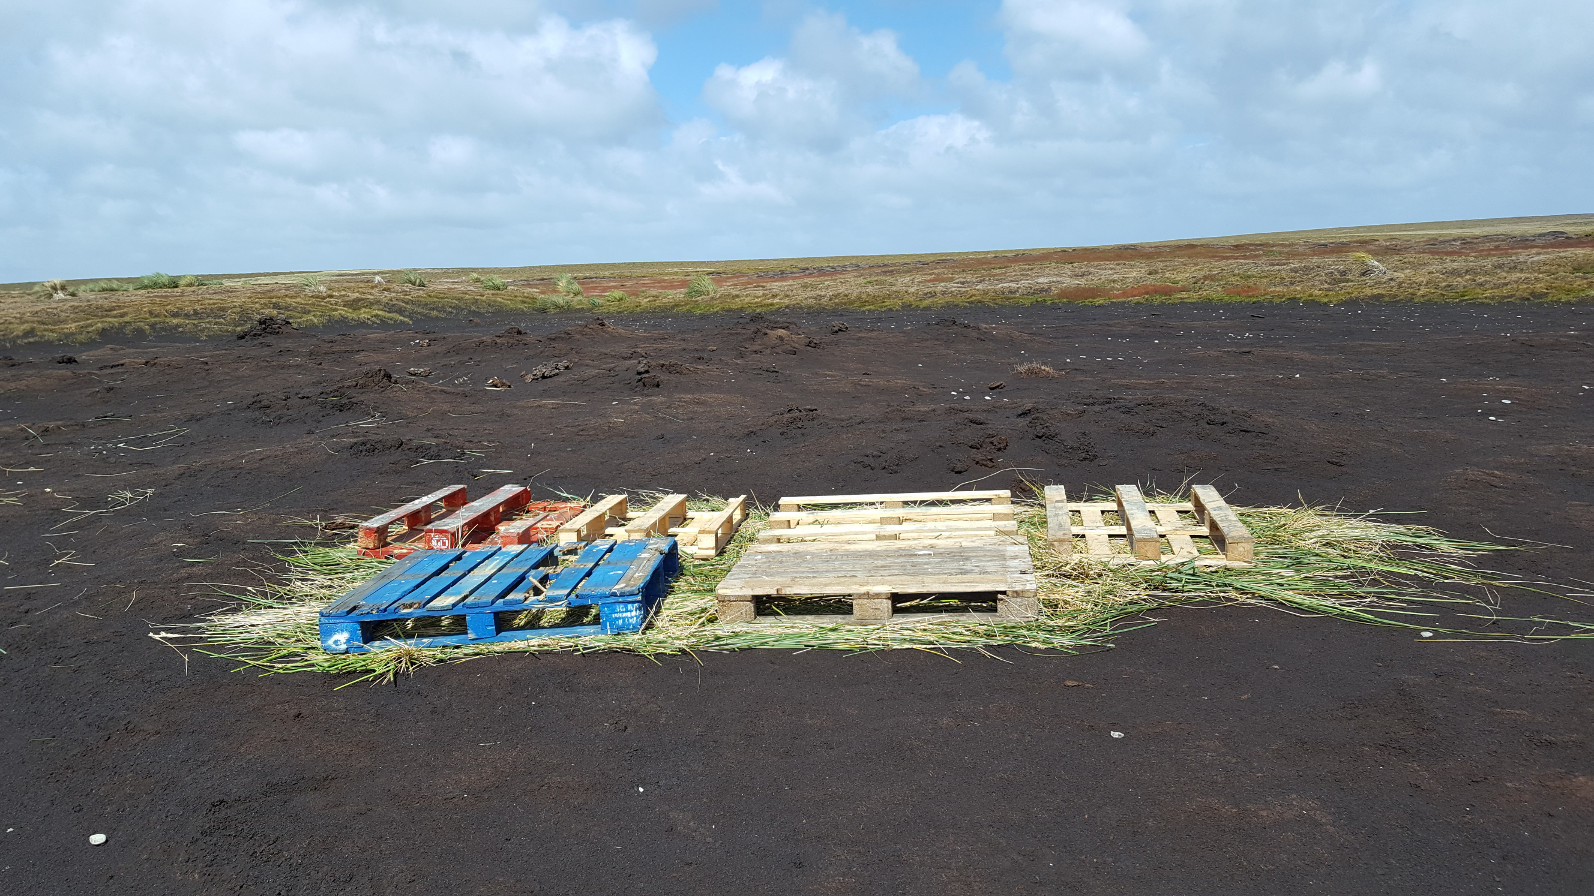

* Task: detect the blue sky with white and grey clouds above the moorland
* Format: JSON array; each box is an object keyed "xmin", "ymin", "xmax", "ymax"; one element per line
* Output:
[{"xmin": 0, "ymin": 0, "xmax": 1594, "ymax": 282}]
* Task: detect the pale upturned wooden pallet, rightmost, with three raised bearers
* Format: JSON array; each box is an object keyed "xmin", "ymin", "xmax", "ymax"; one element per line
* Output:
[{"xmin": 1046, "ymin": 485, "xmax": 1256, "ymax": 566}]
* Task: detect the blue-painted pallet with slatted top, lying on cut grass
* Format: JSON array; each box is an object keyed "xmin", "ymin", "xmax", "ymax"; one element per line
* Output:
[{"xmin": 320, "ymin": 537, "xmax": 681, "ymax": 654}]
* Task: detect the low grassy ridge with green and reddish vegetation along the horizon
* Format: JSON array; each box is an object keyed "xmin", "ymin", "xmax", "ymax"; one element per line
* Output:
[{"xmin": 0, "ymin": 215, "xmax": 1594, "ymax": 344}]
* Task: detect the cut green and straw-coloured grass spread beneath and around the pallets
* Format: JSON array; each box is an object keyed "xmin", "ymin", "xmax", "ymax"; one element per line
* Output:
[{"xmin": 180, "ymin": 499, "xmax": 1594, "ymax": 681}]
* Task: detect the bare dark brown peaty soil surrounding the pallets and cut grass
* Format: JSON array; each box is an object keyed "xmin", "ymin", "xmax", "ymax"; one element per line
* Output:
[{"xmin": 0, "ymin": 305, "xmax": 1594, "ymax": 896}]
